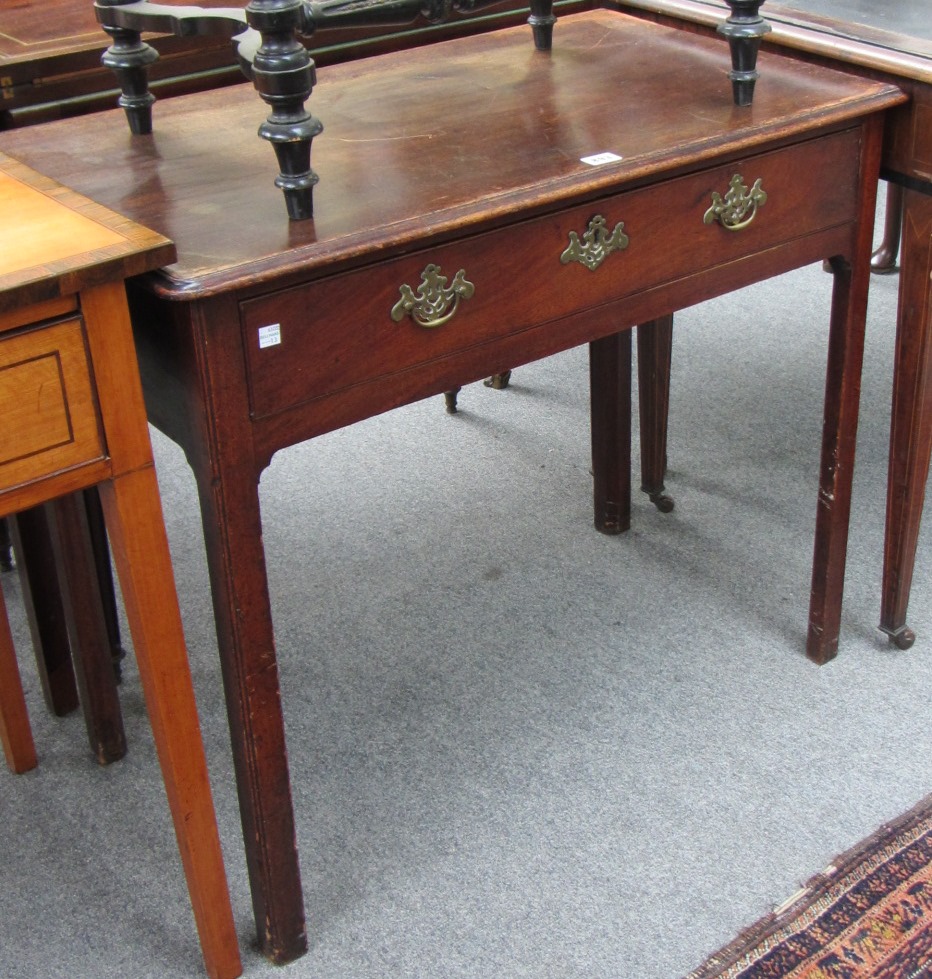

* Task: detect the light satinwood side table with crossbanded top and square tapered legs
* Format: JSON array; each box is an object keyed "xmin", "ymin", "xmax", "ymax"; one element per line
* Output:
[{"xmin": 0, "ymin": 154, "xmax": 241, "ymax": 979}]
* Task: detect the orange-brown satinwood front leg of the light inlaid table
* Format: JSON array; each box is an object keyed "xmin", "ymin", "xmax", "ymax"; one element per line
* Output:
[{"xmin": 80, "ymin": 283, "xmax": 242, "ymax": 979}]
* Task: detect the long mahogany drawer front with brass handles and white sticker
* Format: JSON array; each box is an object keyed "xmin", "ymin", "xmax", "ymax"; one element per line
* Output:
[{"xmin": 241, "ymin": 130, "xmax": 859, "ymax": 417}]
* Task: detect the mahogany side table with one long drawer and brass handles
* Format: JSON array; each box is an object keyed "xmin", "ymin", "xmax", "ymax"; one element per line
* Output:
[{"xmin": 0, "ymin": 11, "xmax": 903, "ymax": 961}]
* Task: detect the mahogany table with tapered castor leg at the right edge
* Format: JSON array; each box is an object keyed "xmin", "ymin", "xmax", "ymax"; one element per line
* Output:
[{"xmin": 613, "ymin": 0, "xmax": 932, "ymax": 649}]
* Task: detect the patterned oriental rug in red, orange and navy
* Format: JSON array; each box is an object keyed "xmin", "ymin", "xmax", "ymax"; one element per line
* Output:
[{"xmin": 686, "ymin": 796, "xmax": 932, "ymax": 979}]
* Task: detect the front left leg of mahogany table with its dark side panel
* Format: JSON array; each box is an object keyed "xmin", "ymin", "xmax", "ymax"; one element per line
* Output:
[{"xmin": 129, "ymin": 289, "xmax": 307, "ymax": 964}]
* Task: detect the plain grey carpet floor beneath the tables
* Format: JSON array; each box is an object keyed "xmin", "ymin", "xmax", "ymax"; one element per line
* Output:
[{"xmin": 0, "ymin": 243, "xmax": 932, "ymax": 979}]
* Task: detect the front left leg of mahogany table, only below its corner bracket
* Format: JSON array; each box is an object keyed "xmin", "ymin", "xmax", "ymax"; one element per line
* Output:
[{"xmin": 197, "ymin": 462, "xmax": 307, "ymax": 964}]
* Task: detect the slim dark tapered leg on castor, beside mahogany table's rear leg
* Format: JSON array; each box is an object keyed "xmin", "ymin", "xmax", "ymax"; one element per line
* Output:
[{"xmin": 637, "ymin": 315, "xmax": 673, "ymax": 513}]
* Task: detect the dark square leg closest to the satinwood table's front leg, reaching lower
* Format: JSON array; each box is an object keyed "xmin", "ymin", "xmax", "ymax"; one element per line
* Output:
[{"xmin": 46, "ymin": 493, "xmax": 126, "ymax": 765}]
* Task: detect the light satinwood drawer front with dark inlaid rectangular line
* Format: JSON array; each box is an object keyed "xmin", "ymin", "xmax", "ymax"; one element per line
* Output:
[{"xmin": 0, "ymin": 318, "xmax": 104, "ymax": 492}]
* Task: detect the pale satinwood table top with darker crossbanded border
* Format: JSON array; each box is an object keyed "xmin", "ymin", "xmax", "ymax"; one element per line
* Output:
[{"xmin": 0, "ymin": 153, "xmax": 175, "ymax": 312}]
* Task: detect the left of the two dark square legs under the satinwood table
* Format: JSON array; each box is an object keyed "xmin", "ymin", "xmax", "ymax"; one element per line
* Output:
[{"xmin": 11, "ymin": 506, "xmax": 79, "ymax": 717}]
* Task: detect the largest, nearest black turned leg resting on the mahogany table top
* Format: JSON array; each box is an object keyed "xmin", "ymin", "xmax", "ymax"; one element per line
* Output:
[{"xmin": 246, "ymin": 0, "xmax": 323, "ymax": 221}]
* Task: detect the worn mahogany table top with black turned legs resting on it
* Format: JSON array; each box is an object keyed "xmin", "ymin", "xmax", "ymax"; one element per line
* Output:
[{"xmin": 0, "ymin": 10, "xmax": 902, "ymax": 299}]
